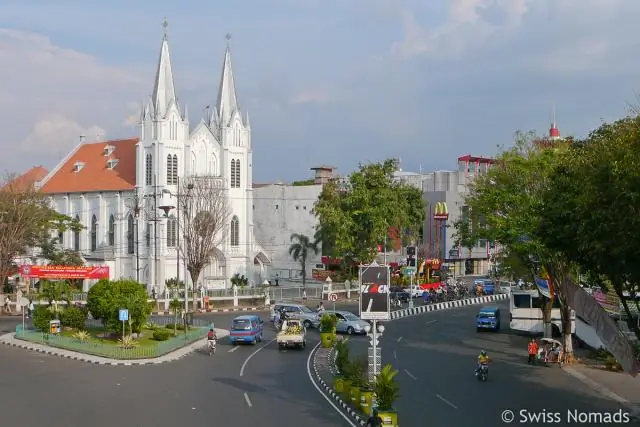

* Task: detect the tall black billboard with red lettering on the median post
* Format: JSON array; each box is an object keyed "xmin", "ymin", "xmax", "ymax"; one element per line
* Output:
[{"xmin": 360, "ymin": 264, "xmax": 391, "ymax": 320}]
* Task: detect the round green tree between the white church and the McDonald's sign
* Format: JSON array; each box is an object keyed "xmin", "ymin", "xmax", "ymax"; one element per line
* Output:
[{"xmin": 313, "ymin": 160, "xmax": 425, "ymax": 263}]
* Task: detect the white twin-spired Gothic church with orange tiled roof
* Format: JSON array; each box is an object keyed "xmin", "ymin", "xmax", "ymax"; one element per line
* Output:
[{"xmin": 29, "ymin": 24, "xmax": 270, "ymax": 291}]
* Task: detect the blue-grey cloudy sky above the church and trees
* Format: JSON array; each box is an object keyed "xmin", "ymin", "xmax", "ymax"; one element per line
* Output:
[{"xmin": 0, "ymin": 0, "xmax": 640, "ymax": 182}]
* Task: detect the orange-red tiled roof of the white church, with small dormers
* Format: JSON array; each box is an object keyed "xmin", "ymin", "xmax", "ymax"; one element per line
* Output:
[{"xmin": 41, "ymin": 138, "xmax": 138, "ymax": 194}]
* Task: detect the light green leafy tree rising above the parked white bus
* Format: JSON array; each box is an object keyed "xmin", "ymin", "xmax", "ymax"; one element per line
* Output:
[{"xmin": 455, "ymin": 132, "xmax": 572, "ymax": 355}]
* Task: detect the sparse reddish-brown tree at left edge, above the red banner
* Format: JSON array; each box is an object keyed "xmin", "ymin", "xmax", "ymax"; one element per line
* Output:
[{"xmin": 0, "ymin": 175, "xmax": 73, "ymax": 288}]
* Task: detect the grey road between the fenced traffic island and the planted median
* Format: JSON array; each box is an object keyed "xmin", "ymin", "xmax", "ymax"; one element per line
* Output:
[{"xmin": 0, "ymin": 306, "xmax": 356, "ymax": 427}]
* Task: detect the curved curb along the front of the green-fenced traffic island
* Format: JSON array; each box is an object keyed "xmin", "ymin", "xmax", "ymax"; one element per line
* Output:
[{"xmin": 0, "ymin": 328, "xmax": 229, "ymax": 366}]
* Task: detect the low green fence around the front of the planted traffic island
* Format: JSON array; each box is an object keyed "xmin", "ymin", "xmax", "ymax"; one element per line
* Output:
[{"xmin": 15, "ymin": 319, "xmax": 212, "ymax": 360}]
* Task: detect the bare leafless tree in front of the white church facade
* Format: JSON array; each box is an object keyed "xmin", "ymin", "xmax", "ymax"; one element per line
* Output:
[{"xmin": 178, "ymin": 176, "xmax": 230, "ymax": 307}]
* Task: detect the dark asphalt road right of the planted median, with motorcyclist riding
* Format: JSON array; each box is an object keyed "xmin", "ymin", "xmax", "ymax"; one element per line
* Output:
[{"xmin": 354, "ymin": 304, "xmax": 632, "ymax": 427}]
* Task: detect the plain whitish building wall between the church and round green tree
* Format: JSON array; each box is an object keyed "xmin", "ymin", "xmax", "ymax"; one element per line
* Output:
[{"xmin": 253, "ymin": 184, "xmax": 322, "ymax": 276}]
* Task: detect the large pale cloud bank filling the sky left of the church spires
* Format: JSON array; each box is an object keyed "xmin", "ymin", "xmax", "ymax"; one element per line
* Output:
[{"xmin": 0, "ymin": 28, "xmax": 144, "ymax": 171}]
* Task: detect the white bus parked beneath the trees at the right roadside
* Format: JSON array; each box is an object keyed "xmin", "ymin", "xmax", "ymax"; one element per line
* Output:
[{"xmin": 509, "ymin": 290, "xmax": 576, "ymax": 334}]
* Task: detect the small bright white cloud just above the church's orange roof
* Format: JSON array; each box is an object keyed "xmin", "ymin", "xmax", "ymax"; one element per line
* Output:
[{"xmin": 21, "ymin": 114, "xmax": 106, "ymax": 155}]
